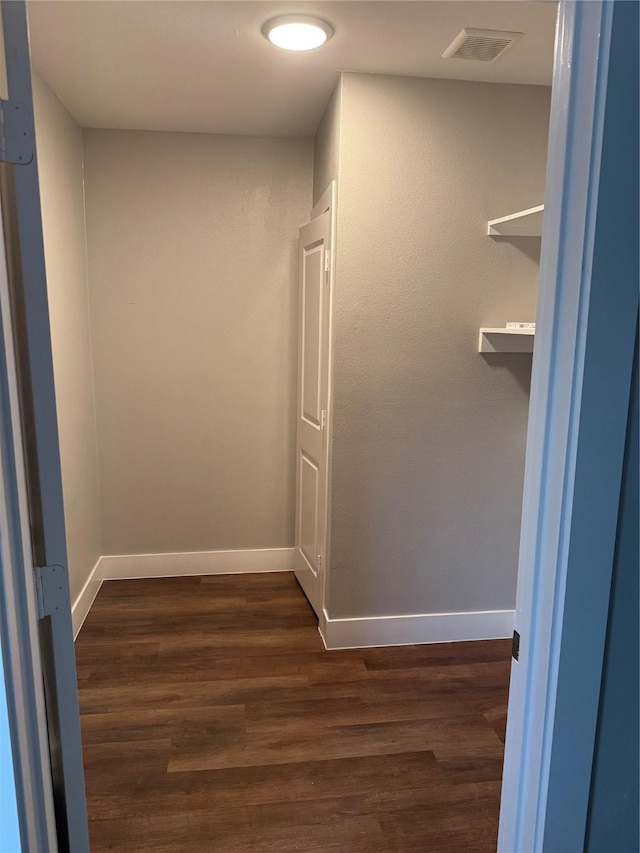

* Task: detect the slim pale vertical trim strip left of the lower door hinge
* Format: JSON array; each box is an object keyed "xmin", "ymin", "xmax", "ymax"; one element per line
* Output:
[{"xmin": 0, "ymin": 193, "xmax": 58, "ymax": 853}]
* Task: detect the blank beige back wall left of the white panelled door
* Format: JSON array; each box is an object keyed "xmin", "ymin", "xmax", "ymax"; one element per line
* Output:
[{"xmin": 84, "ymin": 130, "xmax": 313, "ymax": 554}]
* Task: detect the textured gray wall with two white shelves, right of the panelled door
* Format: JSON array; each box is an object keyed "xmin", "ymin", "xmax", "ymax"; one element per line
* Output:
[{"xmin": 329, "ymin": 74, "xmax": 550, "ymax": 618}]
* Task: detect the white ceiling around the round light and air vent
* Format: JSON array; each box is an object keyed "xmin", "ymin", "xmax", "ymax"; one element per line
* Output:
[{"xmin": 28, "ymin": 0, "xmax": 556, "ymax": 136}]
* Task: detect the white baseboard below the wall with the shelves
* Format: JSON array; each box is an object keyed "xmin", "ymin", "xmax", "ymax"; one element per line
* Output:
[{"xmin": 319, "ymin": 610, "xmax": 514, "ymax": 649}]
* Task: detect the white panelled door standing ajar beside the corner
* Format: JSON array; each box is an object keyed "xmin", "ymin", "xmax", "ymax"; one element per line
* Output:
[{"xmin": 295, "ymin": 211, "xmax": 331, "ymax": 616}]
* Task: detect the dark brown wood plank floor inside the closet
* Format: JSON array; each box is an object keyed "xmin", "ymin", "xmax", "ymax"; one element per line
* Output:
[{"xmin": 76, "ymin": 573, "xmax": 510, "ymax": 853}]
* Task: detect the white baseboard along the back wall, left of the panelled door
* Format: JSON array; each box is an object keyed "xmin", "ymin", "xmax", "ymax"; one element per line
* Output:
[{"xmin": 100, "ymin": 548, "xmax": 294, "ymax": 580}]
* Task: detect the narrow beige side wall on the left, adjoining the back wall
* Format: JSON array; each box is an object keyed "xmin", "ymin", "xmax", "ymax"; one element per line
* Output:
[{"xmin": 33, "ymin": 74, "xmax": 101, "ymax": 599}]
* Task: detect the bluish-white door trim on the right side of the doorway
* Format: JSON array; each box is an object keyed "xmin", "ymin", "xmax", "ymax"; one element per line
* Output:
[{"xmin": 498, "ymin": 0, "xmax": 638, "ymax": 853}]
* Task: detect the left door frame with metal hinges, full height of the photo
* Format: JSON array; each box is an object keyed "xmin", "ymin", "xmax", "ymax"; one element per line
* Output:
[{"xmin": 0, "ymin": 0, "xmax": 89, "ymax": 853}]
